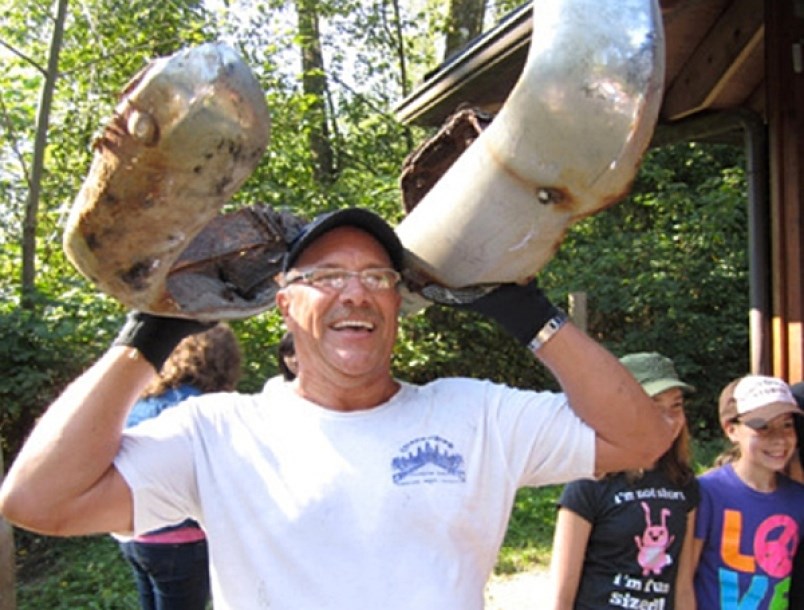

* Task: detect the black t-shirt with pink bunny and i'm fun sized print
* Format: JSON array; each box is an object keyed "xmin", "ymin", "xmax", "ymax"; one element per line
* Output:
[{"xmin": 559, "ymin": 470, "xmax": 699, "ymax": 610}]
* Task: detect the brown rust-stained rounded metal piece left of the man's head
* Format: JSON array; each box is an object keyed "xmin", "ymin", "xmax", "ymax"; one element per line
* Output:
[{"xmin": 64, "ymin": 43, "xmax": 272, "ymax": 318}]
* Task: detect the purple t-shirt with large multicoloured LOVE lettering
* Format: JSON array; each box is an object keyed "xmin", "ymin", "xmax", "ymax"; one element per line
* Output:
[{"xmin": 695, "ymin": 464, "xmax": 804, "ymax": 610}]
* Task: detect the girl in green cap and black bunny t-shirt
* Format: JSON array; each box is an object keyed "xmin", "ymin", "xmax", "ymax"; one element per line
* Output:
[{"xmin": 548, "ymin": 352, "xmax": 698, "ymax": 610}]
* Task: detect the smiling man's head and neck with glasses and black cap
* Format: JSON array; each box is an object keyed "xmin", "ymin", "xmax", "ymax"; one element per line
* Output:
[{"xmin": 276, "ymin": 209, "xmax": 403, "ymax": 411}]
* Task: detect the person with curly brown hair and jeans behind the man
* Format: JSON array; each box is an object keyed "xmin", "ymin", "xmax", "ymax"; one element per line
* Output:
[{"xmin": 118, "ymin": 324, "xmax": 241, "ymax": 610}]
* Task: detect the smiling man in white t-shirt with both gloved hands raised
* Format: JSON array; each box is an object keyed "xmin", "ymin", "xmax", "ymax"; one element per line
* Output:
[{"xmin": 0, "ymin": 209, "xmax": 672, "ymax": 610}]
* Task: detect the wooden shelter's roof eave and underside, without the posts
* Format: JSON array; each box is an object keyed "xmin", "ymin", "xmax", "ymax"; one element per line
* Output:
[{"xmin": 396, "ymin": 0, "xmax": 765, "ymax": 141}]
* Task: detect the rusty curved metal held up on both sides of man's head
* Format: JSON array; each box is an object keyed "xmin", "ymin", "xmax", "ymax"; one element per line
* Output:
[{"xmin": 64, "ymin": 0, "xmax": 663, "ymax": 319}]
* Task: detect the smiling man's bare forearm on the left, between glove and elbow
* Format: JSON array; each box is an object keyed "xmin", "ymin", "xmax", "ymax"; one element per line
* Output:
[{"xmin": 0, "ymin": 347, "xmax": 155, "ymax": 531}]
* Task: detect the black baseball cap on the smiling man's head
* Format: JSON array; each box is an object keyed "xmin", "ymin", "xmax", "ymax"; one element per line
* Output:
[{"xmin": 282, "ymin": 208, "xmax": 405, "ymax": 272}]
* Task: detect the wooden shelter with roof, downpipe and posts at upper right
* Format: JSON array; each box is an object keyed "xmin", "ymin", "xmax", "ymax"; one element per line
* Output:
[{"xmin": 395, "ymin": 0, "xmax": 804, "ymax": 381}]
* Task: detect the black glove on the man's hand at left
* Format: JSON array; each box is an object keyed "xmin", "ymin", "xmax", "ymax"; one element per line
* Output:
[{"xmin": 112, "ymin": 311, "xmax": 217, "ymax": 371}]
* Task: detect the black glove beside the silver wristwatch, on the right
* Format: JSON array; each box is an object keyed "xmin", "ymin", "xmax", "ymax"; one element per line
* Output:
[{"xmin": 459, "ymin": 279, "xmax": 560, "ymax": 345}]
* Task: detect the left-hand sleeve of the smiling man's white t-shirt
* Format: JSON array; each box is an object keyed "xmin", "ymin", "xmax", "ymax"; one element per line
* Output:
[{"xmin": 114, "ymin": 406, "xmax": 198, "ymax": 534}]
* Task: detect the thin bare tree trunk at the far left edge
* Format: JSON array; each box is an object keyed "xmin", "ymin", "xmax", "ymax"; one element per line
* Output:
[{"xmin": 21, "ymin": 0, "xmax": 68, "ymax": 309}]
